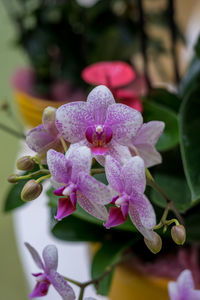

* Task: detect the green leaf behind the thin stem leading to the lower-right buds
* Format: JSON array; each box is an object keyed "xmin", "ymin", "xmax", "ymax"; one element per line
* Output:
[{"xmin": 151, "ymin": 173, "xmax": 191, "ymax": 213}]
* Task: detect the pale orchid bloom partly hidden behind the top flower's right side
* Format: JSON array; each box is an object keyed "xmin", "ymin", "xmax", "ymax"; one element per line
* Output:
[{"xmin": 130, "ymin": 121, "xmax": 165, "ymax": 168}]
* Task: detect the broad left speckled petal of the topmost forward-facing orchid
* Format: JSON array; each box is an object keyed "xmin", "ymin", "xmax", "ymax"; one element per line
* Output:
[{"xmin": 56, "ymin": 101, "xmax": 94, "ymax": 143}]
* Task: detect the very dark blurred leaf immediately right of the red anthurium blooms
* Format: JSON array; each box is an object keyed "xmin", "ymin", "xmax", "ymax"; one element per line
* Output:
[{"xmin": 145, "ymin": 88, "xmax": 181, "ymax": 113}]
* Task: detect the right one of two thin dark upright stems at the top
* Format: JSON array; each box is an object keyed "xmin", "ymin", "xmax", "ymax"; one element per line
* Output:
[{"xmin": 168, "ymin": 0, "xmax": 180, "ymax": 84}]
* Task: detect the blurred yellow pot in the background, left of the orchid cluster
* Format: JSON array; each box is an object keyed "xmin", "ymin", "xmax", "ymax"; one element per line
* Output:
[{"xmin": 14, "ymin": 89, "xmax": 66, "ymax": 127}]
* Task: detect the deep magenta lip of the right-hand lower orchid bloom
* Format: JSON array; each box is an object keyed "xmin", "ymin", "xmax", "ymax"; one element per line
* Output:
[{"xmin": 104, "ymin": 207, "xmax": 126, "ymax": 229}]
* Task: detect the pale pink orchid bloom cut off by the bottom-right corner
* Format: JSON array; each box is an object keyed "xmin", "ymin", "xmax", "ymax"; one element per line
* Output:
[{"xmin": 168, "ymin": 269, "xmax": 200, "ymax": 300}]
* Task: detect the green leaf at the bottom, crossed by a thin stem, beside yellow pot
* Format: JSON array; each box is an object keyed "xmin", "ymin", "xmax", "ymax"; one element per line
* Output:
[{"xmin": 91, "ymin": 242, "xmax": 134, "ymax": 296}]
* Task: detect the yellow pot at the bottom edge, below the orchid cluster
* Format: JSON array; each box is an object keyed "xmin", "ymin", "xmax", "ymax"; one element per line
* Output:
[{"xmin": 109, "ymin": 266, "xmax": 169, "ymax": 300}]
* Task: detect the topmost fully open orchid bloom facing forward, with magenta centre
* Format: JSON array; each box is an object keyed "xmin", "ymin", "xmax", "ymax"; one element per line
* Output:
[{"xmin": 56, "ymin": 85, "xmax": 142, "ymax": 165}]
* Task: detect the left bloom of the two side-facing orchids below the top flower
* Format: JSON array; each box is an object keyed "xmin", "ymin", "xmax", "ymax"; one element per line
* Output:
[{"xmin": 47, "ymin": 146, "xmax": 111, "ymax": 220}]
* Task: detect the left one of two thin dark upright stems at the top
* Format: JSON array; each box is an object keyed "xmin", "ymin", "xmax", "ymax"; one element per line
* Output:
[{"xmin": 137, "ymin": 0, "xmax": 151, "ymax": 89}]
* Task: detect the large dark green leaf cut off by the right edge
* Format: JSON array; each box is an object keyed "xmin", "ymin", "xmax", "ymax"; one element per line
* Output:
[{"xmin": 179, "ymin": 86, "xmax": 200, "ymax": 202}]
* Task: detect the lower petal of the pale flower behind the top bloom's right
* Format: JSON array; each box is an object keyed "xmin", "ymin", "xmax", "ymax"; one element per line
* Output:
[{"xmin": 133, "ymin": 144, "xmax": 162, "ymax": 168}]
